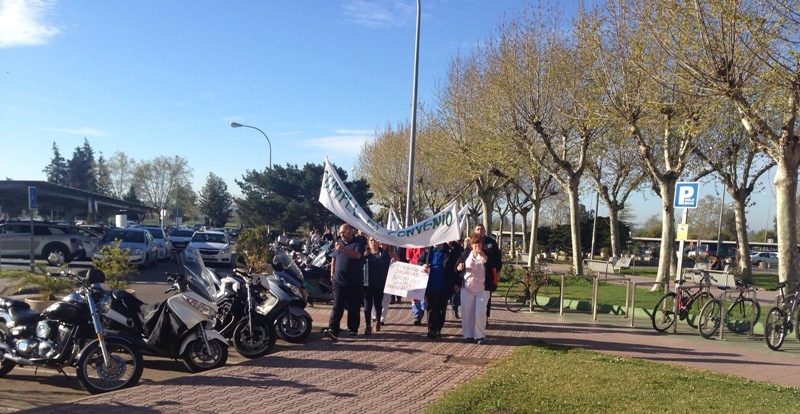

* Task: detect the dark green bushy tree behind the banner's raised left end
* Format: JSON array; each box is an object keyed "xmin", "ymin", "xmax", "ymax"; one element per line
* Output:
[{"xmin": 236, "ymin": 163, "xmax": 372, "ymax": 231}]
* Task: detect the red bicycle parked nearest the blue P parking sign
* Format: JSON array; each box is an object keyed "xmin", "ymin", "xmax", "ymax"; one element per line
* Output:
[{"xmin": 650, "ymin": 271, "xmax": 714, "ymax": 332}]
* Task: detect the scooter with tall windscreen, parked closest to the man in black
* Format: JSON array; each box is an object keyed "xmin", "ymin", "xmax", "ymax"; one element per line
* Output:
[{"xmin": 269, "ymin": 246, "xmax": 312, "ymax": 343}]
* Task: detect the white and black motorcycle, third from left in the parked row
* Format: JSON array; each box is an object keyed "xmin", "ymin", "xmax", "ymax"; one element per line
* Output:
[{"xmin": 214, "ymin": 258, "xmax": 290, "ymax": 358}]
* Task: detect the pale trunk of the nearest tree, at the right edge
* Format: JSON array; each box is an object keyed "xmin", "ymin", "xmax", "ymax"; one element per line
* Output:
[{"xmin": 775, "ymin": 160, "xmax": 800, "ymax": 284}]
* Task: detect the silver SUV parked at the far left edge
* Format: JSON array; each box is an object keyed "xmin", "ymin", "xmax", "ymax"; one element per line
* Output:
[{"xmin": 0, "ymin": 221, "xmax": 85, "ymax": 262}]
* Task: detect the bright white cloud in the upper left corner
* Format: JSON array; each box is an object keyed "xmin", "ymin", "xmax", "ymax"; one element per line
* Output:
[{"xmin": 0, "ymin": 0, "xmax": 61, "ymax": 48}]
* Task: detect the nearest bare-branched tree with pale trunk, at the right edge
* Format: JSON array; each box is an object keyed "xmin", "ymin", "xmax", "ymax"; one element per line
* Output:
[{"xmin": 631, "ymin": 0, "xmax": 800, "ymax": 282}]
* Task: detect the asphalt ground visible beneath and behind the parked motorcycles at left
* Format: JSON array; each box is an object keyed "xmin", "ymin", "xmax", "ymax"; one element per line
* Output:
[{"xmin": 0, "ymin": 259, "xmax": 310, "ymax": 413}]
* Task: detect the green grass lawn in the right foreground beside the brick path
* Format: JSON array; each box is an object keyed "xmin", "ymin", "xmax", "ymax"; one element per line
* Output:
[{"xmin": 425, "ymin": 343, "xmax": 800, "ymax": 414}]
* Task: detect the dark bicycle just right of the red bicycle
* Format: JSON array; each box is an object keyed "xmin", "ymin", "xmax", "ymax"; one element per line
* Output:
[{"xmin": 697, "ymin": 279, "xmax": 761, "ymax": 339}]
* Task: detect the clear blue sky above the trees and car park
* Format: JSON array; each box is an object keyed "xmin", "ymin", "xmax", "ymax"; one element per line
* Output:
[{"xmin": 0, "ymin": 0, "xmax": 774, "ymax": 228}]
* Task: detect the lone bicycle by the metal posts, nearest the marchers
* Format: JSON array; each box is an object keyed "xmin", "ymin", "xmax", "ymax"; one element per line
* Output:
[{"xmin": 505, "ymin": 264, "xmax": 561, "ymax": 312}]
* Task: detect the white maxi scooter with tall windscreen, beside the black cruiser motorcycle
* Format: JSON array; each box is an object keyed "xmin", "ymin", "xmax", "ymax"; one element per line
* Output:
[{"xmin": 102, "ymin": 247, "xmax": 228, "ymax": 372}]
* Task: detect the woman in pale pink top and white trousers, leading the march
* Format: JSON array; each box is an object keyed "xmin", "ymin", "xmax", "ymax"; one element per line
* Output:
[{"xmin": 456, "ymin": 234, "xmax": 491, "ymax": 344}]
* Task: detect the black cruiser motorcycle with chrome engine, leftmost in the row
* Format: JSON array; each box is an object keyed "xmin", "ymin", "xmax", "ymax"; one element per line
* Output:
[{"xmin": 0, "ymin": 257, "xmax": 144, "ymax": 394}]
